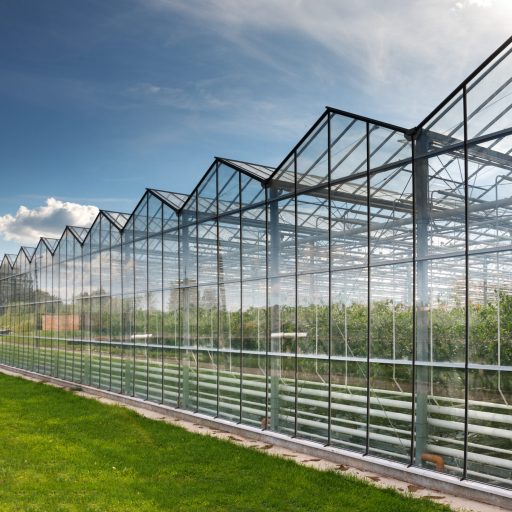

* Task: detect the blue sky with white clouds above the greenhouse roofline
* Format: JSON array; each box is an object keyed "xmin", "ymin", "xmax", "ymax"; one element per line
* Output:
[{"xmin": 0, "ymin": 0, "xmax": 512, "ymax": 253}]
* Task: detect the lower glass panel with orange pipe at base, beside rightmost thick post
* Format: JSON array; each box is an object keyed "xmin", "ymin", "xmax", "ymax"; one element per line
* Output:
[{"xmin": 415, "ymin": 258, "xmax": 466, "ymax": 475}]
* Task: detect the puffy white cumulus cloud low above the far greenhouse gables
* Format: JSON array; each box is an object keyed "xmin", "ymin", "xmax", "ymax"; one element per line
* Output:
[{"xmin": 0, "ymin": 197, "xmax": 98, "ymax": 244}]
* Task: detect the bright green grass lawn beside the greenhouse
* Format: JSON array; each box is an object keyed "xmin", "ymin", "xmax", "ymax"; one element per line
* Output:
[{"xmin": 0, "ymin": 374, "xmax": 449, "ymax": 512}]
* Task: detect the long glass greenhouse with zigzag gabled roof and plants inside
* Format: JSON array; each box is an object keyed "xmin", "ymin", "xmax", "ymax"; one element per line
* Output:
[{"xmin": 0, "ymin": 38, "xmax": 512, "ymax": 496}]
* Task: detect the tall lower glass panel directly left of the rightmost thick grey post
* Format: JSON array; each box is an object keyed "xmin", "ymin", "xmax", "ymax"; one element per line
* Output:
[{"xmin": 369, "ymin": 263, "xmax": 413, "ymax": 463}]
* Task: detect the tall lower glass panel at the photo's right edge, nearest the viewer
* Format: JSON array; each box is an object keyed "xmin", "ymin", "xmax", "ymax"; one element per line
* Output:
[{"xmin": 468, "ymin": 251, "xmax": 512, "ymax": 488}]
